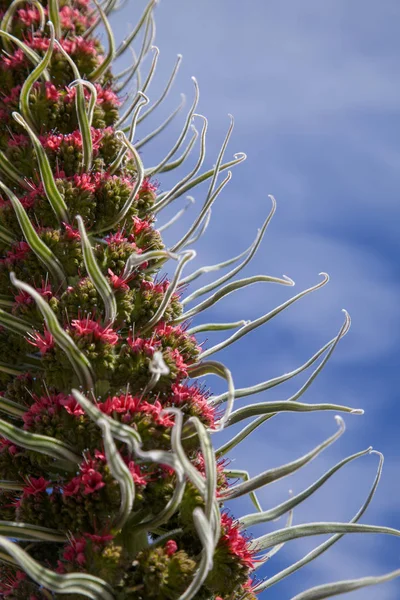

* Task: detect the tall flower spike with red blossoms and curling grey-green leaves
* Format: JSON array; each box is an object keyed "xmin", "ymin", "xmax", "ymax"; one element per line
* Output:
[{"xmin": 0, "ymin": 0, "xmax": 398, "ymax": 600}]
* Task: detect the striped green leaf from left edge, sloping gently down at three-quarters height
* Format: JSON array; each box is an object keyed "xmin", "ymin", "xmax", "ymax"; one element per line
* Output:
[{"xmin": 0, "ymin": 419, "xmax": 82, "ymax": 464}]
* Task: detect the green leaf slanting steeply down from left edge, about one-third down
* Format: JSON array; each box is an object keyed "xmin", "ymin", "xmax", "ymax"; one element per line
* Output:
[{"xmin": 0, "ymin": 181, "xmax": 66, "ymax": 284}]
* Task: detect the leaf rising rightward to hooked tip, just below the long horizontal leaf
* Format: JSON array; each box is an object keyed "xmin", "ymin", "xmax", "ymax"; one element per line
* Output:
[{"xmin": 221, "ymin": 416, "xmax": 345, "ymax": 502}]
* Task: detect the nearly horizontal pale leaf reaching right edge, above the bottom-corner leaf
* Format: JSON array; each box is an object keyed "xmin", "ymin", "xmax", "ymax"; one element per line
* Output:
[{"xmin": 250, "ymin": 523, "xmax": 400, "ymax": 552}]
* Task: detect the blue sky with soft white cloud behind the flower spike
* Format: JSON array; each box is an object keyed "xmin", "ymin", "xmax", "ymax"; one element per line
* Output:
[{"xmin": 113, "ymin": 0, "xmax": 400, "ymax": 600}]
